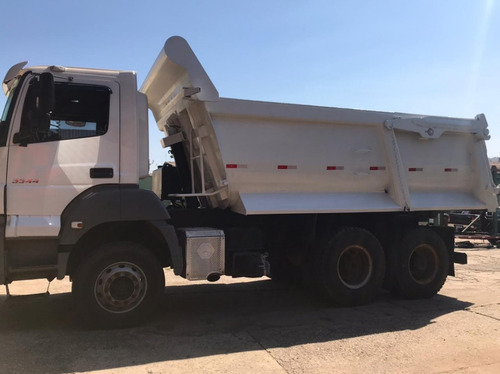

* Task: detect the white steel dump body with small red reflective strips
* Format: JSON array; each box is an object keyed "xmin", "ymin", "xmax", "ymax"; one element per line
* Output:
[{"xmin": 141, "ymin": 37, "xmax": 497, "ymax": 215}]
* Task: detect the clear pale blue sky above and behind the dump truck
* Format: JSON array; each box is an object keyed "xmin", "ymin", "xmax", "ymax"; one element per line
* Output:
[{"xmin": 0, "ymin": 0, "xmax": 500, "ymax": 164}]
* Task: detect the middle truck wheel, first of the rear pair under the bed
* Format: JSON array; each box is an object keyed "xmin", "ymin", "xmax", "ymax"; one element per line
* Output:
[{"xmin": 319, "ymin": 227, "xmax": 385, "ymax": 306}]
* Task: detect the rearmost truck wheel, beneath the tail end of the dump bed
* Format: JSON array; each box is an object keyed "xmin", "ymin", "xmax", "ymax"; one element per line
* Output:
[{"xmin": 392, "ymin": 228, "xmax": 449, "ymax": 299}]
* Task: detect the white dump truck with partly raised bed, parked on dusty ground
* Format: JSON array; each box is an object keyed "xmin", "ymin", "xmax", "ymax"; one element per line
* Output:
[{"xmin": 0, "ymin": 37, "xmax": 497, "ymax": 325}]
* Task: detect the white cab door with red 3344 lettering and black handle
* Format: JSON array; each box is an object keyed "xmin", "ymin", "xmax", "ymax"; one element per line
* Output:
[{"xmin": 6, "ymin": 76, "xmax": 120, "ymax": 237}]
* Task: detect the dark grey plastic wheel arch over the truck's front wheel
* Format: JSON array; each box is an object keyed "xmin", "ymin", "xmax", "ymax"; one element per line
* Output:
[{"xmin": 59, "ymin": 184, "xmax": 184, "ymax": 275}]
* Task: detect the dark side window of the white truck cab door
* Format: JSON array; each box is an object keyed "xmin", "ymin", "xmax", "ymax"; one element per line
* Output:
[{"xmin": 21, "ymin": 82, "xmax": 111, "ymax": 143}]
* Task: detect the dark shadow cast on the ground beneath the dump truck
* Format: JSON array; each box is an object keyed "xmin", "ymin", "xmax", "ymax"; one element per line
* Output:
[{"xmin": 0, "ymin": 280, "xmax": 471, "ymax": 373}]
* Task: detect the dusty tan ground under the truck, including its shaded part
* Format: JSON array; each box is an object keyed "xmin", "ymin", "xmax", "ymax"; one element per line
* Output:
[{"xmin": 0, "ymin": 244, "xmax": 500, "ymax": 374}]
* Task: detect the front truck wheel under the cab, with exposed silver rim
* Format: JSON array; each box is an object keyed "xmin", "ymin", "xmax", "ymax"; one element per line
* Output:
[{"xmin": 72, "ymin": 242, "xmax": 165, "ymax": 327}]
